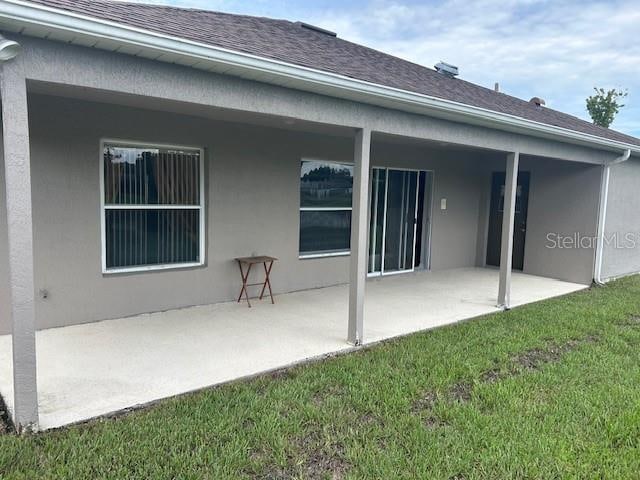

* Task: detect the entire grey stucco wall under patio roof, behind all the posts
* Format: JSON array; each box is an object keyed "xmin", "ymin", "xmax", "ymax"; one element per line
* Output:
[{"xmin": 0, "ymin": 95, "xmax": 597, "ymax": 333}]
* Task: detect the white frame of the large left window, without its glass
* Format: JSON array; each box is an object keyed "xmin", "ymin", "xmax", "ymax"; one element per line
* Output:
[{"xmin": 99, "ymin": 138, "xmax": 206, "ymax": 275}]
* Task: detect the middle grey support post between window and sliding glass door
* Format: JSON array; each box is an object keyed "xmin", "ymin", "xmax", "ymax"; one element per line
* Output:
[{"xmin": 347, "ymin": 129, "xmax": 371, "ymax": 345}]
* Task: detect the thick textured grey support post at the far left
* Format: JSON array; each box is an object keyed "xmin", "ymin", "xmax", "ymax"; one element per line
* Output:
[{"xmin": 0, "ymin": 61, "xmax": 38, "ymax": 431}]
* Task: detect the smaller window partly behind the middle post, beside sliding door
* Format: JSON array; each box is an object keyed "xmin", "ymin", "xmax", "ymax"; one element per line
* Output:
[{"xmin": 300, "ymin": 160, "xmax": 353, "ymax": 257}]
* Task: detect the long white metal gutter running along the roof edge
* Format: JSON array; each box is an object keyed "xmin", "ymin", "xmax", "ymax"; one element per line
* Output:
[{"xmin": 0, "ymin": 0, "xmax": 640, "ymax": 154}]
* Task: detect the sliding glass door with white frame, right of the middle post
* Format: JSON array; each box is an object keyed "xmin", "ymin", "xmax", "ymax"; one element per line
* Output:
[{"xmin": 369, "ymin": 168, "xmax": 421, "ymax": 275}]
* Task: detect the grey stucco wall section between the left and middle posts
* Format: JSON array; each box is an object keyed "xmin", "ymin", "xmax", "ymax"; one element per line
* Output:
[{"xmin": 25, "ymin": 97, "xmax": 352, "ymax": 328}]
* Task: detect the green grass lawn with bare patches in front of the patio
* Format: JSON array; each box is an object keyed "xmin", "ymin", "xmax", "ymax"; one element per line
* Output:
[{"xmin": 0, "ymin": 277, "xmax": 640, "ymax": 479}]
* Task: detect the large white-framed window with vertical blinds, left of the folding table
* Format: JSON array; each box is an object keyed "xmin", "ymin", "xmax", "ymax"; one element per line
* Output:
[{"xmin": 101, "ymin": 142, "xmax": 204, "ymax": 273}]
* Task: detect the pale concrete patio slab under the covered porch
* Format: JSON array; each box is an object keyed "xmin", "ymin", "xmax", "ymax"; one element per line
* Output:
[{"xmin": 0, "ymin": 268, "xmax": 586, "ymax": 429}]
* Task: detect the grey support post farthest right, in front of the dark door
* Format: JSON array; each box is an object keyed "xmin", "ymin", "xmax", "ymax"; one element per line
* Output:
[{"xmin": 498, "ymin": 152, "xmax": 520, "ymax": 309}]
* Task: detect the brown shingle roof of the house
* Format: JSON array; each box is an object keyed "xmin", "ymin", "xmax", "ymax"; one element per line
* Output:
[{"xmin": 20, "ymin": 0, "xmax": 640, "ymax": 145}]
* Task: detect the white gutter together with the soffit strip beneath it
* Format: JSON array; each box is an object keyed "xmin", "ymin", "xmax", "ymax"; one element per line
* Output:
[{"xmin": 0, "ymin": 0, "xmax": 640, "ymax": 154}]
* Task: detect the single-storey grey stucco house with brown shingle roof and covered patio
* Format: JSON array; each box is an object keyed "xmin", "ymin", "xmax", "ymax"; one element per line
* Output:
[{"xmin": 0, "ymin": 0, "xmax": 640, "ymax": 429}]
